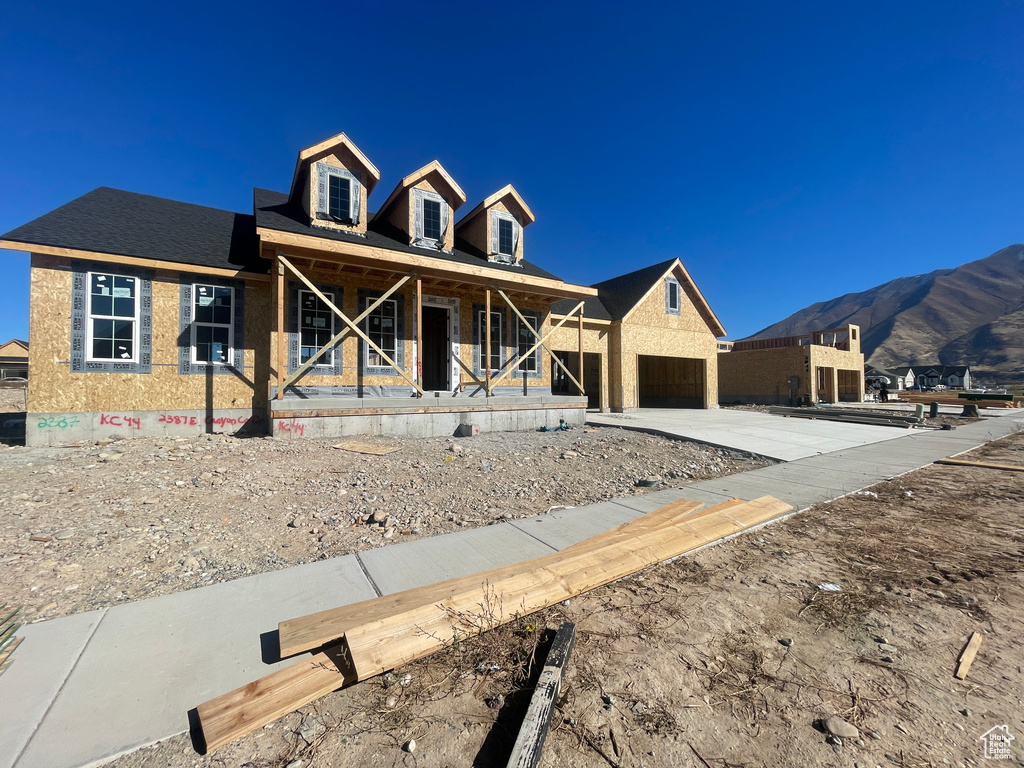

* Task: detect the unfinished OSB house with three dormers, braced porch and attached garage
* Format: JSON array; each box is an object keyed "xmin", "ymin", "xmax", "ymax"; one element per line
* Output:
[{"xmin": 0, "ymin": 134, "xmax": 724, "ymax": 444}]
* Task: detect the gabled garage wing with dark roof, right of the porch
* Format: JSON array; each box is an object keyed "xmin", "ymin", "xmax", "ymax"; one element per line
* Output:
[{"xmin": 552, "ymin": 259, "xmax": 725, "ymax": 412}]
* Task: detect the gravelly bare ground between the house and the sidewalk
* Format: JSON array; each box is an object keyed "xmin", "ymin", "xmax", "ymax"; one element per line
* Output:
[{"xmin": 0, "ymin": 428, "xmax": 765, "ymax": 621}]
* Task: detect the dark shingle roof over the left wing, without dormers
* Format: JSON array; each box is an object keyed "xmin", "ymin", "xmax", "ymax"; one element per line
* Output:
[{"xmin": 3, "ymin": 186, "xmax": 268, "ymax": 272}]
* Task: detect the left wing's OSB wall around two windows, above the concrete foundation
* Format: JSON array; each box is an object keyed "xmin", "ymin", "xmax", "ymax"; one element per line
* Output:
[{"xmin": 28, "ymin": 254, "xmax": 272, "ymax": 414}]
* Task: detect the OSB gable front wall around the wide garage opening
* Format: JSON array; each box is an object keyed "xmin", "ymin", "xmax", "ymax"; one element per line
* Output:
[{"xmin": 611, "ymin": 280, "xmax": 718, "ymax": 409}]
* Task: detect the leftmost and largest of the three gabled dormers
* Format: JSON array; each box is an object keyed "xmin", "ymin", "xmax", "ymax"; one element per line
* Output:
[{"xmin": 289, "ymin": 133, "xmax": 381, "ymax": 234}]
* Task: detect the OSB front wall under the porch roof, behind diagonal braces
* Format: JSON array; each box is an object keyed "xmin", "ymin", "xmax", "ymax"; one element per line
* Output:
[{"xmin": 268, "ymin": 269, "xmax": 551, "ymax": 387}]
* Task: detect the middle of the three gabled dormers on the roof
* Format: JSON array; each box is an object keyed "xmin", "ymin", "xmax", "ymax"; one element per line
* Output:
[{"xmin": 374, "ymin": 160, "xmax": 466, "ymax": 252}]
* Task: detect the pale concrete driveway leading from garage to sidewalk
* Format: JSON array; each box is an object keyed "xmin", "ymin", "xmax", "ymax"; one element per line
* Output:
[{"xmin": 587, "ymin": 409, "xmax": 914, "ymax": 462}]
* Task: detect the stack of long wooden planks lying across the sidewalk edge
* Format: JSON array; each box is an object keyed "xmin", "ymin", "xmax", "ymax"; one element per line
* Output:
[{"xmin": 197, "ymin": 497, "xmax": 792, "ymax": 752}]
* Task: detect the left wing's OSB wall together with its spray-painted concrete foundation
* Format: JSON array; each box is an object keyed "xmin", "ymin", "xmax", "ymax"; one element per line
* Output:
[{"xmin": 27, "ymin": 254, "xmax": 271, "ymax": 444}]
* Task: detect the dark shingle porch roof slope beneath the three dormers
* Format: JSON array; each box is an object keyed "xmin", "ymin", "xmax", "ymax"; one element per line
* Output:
[{"xmin": 253, "ymin": 188, "xmax": 561, "ymax": 280}]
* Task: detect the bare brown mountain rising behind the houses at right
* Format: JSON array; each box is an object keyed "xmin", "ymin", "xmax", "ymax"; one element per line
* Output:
[{"xmin": 749, "ymin": 245, "xmax": 1024, "ymax": 383}]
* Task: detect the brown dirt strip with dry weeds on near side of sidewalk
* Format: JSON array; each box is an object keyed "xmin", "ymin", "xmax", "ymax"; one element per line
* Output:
[{"xmin": 97, "ymin": 433, "xmax": 1024, "ymax": 768}]
